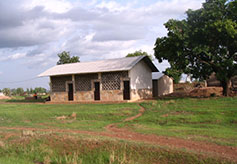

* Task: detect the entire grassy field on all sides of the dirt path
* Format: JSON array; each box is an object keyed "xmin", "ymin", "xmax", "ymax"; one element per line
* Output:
[{"xmin": 0, "ymin": 98, "xmax": 237, "ymax": 164}]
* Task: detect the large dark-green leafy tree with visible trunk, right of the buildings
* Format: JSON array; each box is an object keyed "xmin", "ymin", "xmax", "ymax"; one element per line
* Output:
[{"xmin": 154, "ymin": 0, "xmax": 237, "ymax": 95}]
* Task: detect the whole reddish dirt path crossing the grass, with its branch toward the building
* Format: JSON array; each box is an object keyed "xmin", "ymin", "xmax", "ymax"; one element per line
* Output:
[{"xmin": 0, "ymin": 106, "xmax": 237, "ymax": 162}]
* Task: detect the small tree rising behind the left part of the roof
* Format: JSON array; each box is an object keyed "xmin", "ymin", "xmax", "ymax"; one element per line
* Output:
[{"xmin": 57, "ymin": 51, "xmax": 80, "ymax": 65}]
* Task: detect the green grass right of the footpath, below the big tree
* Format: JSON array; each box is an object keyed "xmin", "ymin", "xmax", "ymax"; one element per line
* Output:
[{"xmin": 123, "ymin": 97, "xmax": 237, "ymax": 146}]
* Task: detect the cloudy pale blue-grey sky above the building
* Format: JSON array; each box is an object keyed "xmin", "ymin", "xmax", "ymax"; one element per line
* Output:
[{"xmin": 0, "ymin": 0, "xmax": 204, "ymax": 89}]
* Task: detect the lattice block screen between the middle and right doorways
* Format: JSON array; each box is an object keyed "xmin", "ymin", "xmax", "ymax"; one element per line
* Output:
[{"xmin": 101, "ymin": 71, "xmax": 128, "ymax": 90}]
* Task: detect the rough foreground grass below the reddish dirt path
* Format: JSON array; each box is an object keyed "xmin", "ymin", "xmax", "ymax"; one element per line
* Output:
[{"xmin": 0, "ymin": 134, "xmax": 230, "ymax": 164}]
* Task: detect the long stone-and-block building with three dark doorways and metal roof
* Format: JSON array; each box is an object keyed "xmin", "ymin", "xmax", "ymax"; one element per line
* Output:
[{"xmin": 39, "ymin": 56, "xmax": 158, "ymax": 102}]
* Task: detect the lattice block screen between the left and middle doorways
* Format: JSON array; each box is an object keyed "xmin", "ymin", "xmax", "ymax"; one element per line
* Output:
[{"xmin": 75, "ymin": 73, "xmax": 98, "ymax": 91}]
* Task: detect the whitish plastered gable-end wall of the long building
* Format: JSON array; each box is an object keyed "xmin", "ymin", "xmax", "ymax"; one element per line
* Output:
[{"xmin": 128, "ymin": 61, "xmax": 152, "ymax": 89}]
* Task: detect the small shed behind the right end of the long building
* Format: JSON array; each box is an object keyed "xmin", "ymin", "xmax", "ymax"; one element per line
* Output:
[{"xmin": 152, "ymin": 72, "xmax": 173, "ymax": 97}]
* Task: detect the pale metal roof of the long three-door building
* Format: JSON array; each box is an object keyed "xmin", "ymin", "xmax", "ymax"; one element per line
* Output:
[{"xmin": 38, "ymin": 56, "xmax": 158, "ymax": 77}]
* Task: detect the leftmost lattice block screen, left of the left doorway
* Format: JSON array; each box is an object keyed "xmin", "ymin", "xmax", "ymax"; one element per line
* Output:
[{"xmin": 51, "ymin": 76, "xmax": 72, "ymax": 92}]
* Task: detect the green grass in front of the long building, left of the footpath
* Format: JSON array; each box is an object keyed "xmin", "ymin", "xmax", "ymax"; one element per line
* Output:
[{"xmin": 0, "ymin": 103, "xmax": 139, "ymax": 130}]
